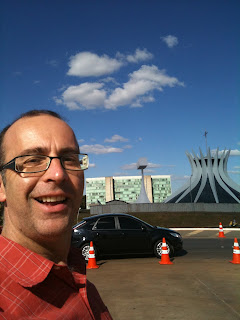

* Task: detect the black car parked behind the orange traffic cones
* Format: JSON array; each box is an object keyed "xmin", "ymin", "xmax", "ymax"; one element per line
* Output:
[{"xmin": 72, "ymin": 214, "xmax": 183, "ymax": 260}]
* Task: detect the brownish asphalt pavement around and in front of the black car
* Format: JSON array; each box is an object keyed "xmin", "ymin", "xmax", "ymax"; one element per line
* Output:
[{"xmin": 87, "ymin": 230, "xmax": 240, "ymax": 320}]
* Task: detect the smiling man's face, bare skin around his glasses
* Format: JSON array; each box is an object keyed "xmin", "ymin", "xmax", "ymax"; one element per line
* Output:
[{"xmin": 0, "ymin": 115, "xmax": 84, "ymax": 242}]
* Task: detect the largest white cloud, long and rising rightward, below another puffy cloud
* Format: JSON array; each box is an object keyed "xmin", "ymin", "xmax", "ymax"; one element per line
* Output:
[{"xmin": 54, "ymin": 65, "xmax": 184, "ymax": 110}]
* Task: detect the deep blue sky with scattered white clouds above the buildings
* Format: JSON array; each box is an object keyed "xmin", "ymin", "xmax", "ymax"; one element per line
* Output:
[{"xmin": 0, "ymin": 0, "xmax": 240, "ymax": 190}]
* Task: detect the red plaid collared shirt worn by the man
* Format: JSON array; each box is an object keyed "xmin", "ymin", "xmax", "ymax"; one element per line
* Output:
[{"xmin": 0, "ymin": 235, "xmax": 112, "ymax": 320}]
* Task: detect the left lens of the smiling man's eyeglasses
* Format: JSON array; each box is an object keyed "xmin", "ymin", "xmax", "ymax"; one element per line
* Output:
[{"xmin": 15, "ymin": 155, "xmax": 49, "ymax": 172}]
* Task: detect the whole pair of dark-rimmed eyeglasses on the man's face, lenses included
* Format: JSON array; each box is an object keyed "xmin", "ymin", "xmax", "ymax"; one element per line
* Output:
[{"xmin": 0, "ymin": 153, "xmax": 89, "ymax": 173}]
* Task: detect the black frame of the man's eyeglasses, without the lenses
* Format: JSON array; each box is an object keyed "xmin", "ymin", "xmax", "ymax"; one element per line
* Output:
[{"xmin": 0, "ymin": 153, "xmax": 89, "ymax": 174}]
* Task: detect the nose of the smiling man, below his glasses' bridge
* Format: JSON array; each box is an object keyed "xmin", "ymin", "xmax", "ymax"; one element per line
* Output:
[{"xmin": 44, "ymin": 158, "xmax": 68, "ymax": 184}]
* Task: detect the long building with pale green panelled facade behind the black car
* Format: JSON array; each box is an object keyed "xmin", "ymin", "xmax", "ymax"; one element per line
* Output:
[{"xmin": 86, "ymin": 175, "xmax": 172, "ymax": 208}]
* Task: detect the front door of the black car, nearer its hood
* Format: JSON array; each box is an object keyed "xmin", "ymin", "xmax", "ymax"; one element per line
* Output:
[{"xmin": 118, "ymin": 216, "xmax": 152, "ymax": 253}]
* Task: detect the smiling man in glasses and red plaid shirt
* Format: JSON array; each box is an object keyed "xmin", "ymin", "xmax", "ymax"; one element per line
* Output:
[{"xmin": 0, "ymin": 110, "xmax": 112, "ymax": 320}]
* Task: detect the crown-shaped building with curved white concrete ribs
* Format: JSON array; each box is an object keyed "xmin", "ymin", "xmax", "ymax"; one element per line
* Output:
[{"xmin": 165, "ymin": 148, "xmax": 240, "ymax": 204}]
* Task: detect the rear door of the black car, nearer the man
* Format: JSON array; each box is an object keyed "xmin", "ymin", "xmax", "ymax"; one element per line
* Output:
[{"xmin": 92, "ymin": 216, "xmax": 121, "ymax": 254}]
